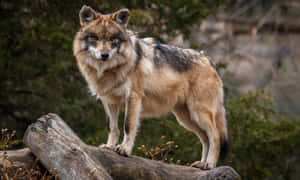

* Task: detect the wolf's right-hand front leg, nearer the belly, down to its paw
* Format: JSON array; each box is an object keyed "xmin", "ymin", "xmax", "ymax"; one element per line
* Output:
[{"xmin": 115, "ymin": 92, "xmax": 141, "ymax": 156}]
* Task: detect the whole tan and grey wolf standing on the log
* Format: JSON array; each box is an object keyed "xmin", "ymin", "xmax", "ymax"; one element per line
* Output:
[{"xmin": 73, "ymin": 5, "xmax": 229, "ymax": 169}]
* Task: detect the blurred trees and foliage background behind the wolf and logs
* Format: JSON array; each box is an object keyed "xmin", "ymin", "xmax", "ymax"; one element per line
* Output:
[{"xmin": 0, "ymin": 0, "xmax": 300, "ymax": 180}]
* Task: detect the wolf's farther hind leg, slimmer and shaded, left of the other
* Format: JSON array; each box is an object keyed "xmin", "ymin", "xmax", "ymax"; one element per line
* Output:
[{"xmin": 173, "ymin": 105, "xmax": 209, "ymax": 165}]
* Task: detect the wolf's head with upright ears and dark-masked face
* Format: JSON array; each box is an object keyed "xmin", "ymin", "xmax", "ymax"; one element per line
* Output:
[{"xmin": 74, "ymin": 5, "xmax": 130, "ymax": 62}]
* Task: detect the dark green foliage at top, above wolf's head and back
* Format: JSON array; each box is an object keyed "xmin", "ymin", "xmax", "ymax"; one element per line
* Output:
[{"xmin": 96, "ymin": 0, "xmax": 223, "ymax": 39}]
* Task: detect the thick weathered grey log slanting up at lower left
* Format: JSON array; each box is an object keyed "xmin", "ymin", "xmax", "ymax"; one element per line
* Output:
[{"xmin": 24, "ymin": 114, "xmax": 112, "ymax": 180}]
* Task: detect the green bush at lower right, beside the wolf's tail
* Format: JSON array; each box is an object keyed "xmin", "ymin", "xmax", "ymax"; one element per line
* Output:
[{"xmin": 226, "ymin": 92, "xmax": 300, "ymax": 179}]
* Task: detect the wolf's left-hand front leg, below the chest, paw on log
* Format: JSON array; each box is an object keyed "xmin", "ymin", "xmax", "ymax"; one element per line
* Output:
[{"xmin": 100, "ymin": 103, "xmax": 120, "ymax": 149}]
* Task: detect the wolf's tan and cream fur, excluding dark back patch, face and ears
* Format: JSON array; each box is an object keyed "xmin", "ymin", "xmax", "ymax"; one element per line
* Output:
[{"xmin": 73, "ymin": 5, "xmax": 227, "ymax": 169}]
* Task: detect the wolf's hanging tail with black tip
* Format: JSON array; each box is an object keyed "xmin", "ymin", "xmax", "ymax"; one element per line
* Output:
[{"xmin": 216, "ymin": 106, "xmax": 230, "ymax": 160}]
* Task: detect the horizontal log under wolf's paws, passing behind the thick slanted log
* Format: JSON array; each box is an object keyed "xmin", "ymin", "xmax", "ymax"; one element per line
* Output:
[{"xmin": 0, "ymin": 146, "xmax": 239, "ymax": 180}]
